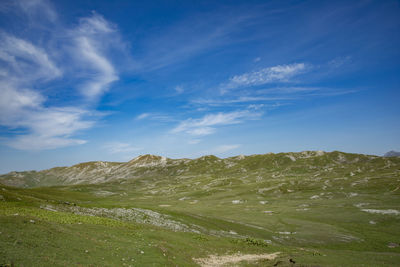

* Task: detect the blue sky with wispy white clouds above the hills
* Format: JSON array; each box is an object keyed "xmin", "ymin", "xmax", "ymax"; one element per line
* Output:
[{"xmin": 0, "ymin": 0, "xmax": 400, "ymax": 173}]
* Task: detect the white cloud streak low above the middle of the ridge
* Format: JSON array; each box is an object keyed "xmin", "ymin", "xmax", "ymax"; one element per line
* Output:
[{"xmin": 171, "ymin": 110, "xmax": 262, "ymax": 135}]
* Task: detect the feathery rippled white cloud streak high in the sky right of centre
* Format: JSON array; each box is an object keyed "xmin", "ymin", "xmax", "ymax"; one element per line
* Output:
[{"xmin": 221, "ymin": 63, "xmax": 308, "ymax": 93}]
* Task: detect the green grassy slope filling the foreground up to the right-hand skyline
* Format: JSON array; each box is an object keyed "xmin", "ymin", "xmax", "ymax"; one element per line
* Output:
[{"xmin": 0, "ymin": 152, "xmax": 400, "ymax": 266}]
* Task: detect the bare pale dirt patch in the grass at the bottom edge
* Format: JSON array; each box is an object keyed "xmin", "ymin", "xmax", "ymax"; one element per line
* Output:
[{"xmin": 193, "ymin": 252, "xmax": 280, "ymax": 267}]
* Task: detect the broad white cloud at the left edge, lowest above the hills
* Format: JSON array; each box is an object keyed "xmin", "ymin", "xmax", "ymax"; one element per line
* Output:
[{"xmin": 0, "ymin": 88, "xmax": 94, "ymax": 150}]
